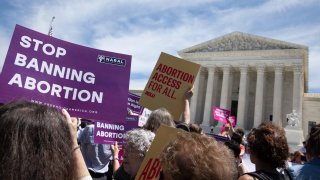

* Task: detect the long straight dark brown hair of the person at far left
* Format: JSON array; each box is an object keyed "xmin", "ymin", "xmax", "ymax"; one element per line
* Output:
[{"xmin": 0, "ymin": 101, "xmax": 74, "ymax": 179}]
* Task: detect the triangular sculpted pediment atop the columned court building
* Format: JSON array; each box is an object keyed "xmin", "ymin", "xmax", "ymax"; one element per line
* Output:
[{"xmin": 179, "ymin": 32, "xmax": 307, "ymax": 53}]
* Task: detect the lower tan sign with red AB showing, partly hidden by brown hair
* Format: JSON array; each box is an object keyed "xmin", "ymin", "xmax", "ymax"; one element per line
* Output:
[{"xmin": 135, "ymin": 125, "xmax": 184, "ymax": 180}]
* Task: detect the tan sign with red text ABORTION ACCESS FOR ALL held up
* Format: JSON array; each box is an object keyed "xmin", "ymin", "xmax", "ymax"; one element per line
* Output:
[{"xmin": 139, "ymin": 52, "xmax": 200, "ymax": 120}]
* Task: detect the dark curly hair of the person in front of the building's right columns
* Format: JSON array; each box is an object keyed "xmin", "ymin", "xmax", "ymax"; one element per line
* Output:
[{"xmin": 248, "ymin": 122, "xmax": 289, "ymax": 168}]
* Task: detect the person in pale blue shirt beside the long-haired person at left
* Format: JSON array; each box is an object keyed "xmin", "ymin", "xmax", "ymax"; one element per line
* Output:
[{"xmin": 78, "ymin": 123, "xmax": 112, "ymax": 180}]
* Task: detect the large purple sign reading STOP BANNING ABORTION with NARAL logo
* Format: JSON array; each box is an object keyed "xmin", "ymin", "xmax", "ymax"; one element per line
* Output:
[{"xmin": 0, "ymin": 25, "xmax": 131, "ymax": 122}]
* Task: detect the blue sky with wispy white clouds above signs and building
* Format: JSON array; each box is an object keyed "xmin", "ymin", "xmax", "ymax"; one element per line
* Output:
[{"xmin": 0, "ymin": 0, "xmax": 320, "ymax": 93}]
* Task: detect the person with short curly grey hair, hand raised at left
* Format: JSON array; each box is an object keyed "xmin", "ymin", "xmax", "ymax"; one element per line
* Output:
[{"xmin": 111, "ymin": 129, "xmax": 155, "ymax": 180}]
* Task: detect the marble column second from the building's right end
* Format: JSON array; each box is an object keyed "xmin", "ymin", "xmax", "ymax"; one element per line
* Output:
[{"xmin": 272, "ymin": 64, "xmax": 284, "ymax": 126}]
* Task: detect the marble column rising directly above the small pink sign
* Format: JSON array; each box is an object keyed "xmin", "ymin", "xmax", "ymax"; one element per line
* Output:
[{"xmin": 220, "ymin": 65, "xmax": 231, "ymax": 109}]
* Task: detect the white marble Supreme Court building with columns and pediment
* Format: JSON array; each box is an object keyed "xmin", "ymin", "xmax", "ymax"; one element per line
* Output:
[{"xmin": 178, "ymin": 32, "xmax": 320, "ymax": 144}]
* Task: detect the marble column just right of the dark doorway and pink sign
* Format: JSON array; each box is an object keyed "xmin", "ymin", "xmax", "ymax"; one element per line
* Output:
[{"xmin": 237, "ymin": 64, "xmax": 248, "ymax": 128}]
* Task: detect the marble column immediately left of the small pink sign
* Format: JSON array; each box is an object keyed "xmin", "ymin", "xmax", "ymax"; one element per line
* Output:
[{"xmin": 202, "ymin": 67, "xmax": 215, "ymax": 126}]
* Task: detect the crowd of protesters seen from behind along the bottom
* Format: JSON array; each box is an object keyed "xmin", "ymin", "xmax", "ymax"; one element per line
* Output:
[{"xmin": 0, "ymin": 90, "xmax": 320, "ymax": 180}]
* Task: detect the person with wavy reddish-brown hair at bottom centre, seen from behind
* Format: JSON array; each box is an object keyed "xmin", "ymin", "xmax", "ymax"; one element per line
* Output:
[{"xmin": 160, "ymin": 132, "xmax": 237, "ymax": 180}]
